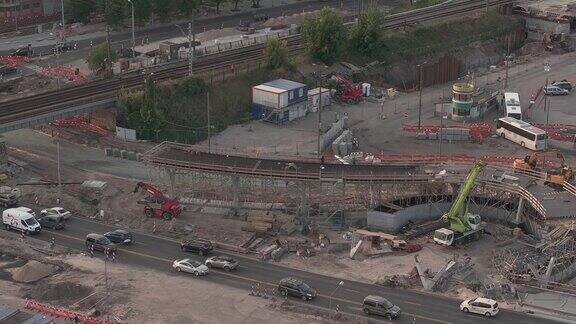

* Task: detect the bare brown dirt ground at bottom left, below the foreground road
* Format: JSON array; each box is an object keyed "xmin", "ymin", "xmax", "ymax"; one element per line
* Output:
[{"xmin": 0, "ymin": 231, "xmax": 360, "ymax": 323}]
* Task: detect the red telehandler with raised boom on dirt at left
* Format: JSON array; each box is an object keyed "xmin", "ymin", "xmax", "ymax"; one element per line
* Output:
[{"xmin": 134, "ymin": 182, "xmax": 182, "ymax": 220}]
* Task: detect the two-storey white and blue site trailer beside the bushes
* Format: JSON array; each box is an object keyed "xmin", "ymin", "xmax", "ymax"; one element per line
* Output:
[{"xmin": 252, "ymin": 79, "xmax": 308, "ymax": 124}]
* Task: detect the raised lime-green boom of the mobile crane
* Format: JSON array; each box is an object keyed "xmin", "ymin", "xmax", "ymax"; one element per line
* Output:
[{"xmin": 442, "ymin": 161, "xmax": 486, "ymax": 233}]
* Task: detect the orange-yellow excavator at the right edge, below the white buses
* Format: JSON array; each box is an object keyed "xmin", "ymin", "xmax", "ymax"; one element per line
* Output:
[{"xmin": 512, "ymin": 150, "xmax": 574, "ymax": 187}]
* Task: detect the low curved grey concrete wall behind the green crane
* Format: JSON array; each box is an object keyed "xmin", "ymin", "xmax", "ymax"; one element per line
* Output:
[{"xmin": 367, "ymin": 202, "xmax": 515, "ymax": 233}]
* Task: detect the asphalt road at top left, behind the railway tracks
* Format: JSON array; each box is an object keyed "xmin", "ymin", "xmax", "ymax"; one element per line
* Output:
[{"xmin": 0, "ymin": 0, "xmax": 356, "ymax": 59}]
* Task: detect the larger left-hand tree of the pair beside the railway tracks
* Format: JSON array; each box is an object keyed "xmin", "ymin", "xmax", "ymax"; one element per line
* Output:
[{"xmin": 301, "ymin": 8, "xmax": 346, "ymax": 65}]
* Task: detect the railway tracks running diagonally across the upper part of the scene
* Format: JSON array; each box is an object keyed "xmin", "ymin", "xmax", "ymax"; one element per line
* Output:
[{"xmin": 0, "ymin": 0, "xmax": 511, "ymax": 124}]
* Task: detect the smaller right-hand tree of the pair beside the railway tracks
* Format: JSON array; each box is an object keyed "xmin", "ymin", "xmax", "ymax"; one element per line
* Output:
[{"xmin": 350, "ymin": 7, "xmax": 383, "ymax": 54}]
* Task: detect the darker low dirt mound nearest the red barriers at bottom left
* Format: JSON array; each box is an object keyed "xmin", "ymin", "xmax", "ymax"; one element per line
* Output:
[{"xmin": 30, "ymin": 281, "xmax": 93, "ymax": 304}]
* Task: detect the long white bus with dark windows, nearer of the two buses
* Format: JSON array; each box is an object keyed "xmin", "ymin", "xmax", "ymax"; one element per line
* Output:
[{"xmin": 496, "ymin": 117, "xmax": 546, "ymax": 151}]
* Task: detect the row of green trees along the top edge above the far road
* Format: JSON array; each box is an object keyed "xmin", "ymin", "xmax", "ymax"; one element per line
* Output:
[{"xmin": 65, "ymin": 0, "xmax": 260, "ymax": 27}]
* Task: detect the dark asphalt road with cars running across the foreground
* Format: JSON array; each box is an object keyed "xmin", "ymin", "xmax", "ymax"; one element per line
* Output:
[{"xmin": 16, "ymin": 216, "xmax": 558, "ymax": 324}]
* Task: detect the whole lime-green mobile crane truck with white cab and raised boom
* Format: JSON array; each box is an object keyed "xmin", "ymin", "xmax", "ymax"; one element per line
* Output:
[{"xmin": 434, "ymin": 161, "xmax": 486, "ymax": 246}]
